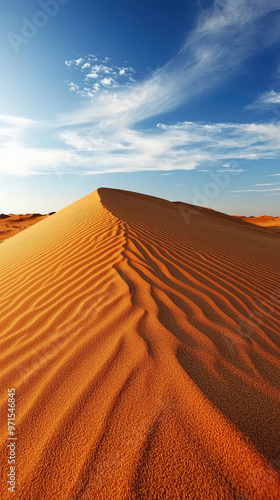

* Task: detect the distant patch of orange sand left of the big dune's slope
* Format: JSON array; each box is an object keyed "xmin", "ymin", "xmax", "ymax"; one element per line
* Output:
[{"xmin": 0, "ymin": 214, "xmax": 49, "ymax": 242}]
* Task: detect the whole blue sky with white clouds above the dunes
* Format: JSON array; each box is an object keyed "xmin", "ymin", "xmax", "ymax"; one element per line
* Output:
[{"xmin": 0, "ymin": 0, "xmax": 280, "ymax": 215}]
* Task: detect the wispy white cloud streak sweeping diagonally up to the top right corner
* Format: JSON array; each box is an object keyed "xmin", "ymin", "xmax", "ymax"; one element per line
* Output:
[{"xmin": 57, "ymin": 0, "xmax": 280, "ymax": 130}]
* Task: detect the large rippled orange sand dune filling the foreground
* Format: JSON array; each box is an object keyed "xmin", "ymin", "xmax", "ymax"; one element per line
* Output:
[{"xmin": 0, "ymin": 189, "xmax": 280, "ymax": 500}]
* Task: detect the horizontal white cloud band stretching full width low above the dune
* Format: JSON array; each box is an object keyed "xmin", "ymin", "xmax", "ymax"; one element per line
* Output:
[{"xmin": 0, "ymin": 117, "xmax": 280, "ymax": 178}]
